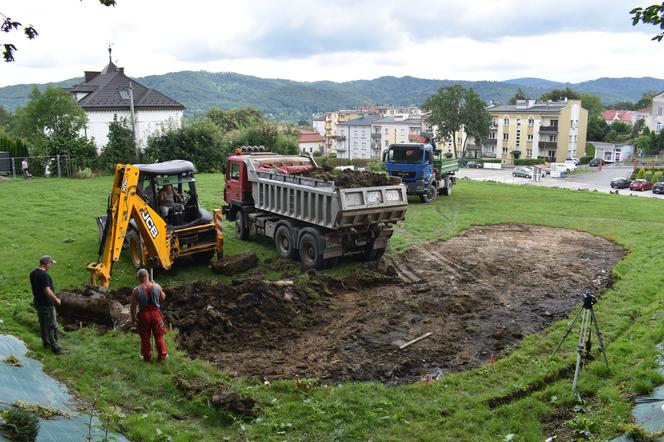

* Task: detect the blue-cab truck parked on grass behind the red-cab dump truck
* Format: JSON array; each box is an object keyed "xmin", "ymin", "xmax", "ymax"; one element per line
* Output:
[{"xmin": 384, "ymin": 143, "xmax": 459, "ymax": 203}]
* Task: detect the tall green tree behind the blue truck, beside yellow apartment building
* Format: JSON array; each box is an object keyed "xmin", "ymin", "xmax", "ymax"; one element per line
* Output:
[{"xmin": 422, "ymin": 85, "xmax": 491, "ymax": 158}]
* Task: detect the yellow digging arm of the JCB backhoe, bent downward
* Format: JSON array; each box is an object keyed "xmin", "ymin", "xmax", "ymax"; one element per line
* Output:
[{"xmin": 88, "ymin": 164, "xmax": 177, "ymax": 287}]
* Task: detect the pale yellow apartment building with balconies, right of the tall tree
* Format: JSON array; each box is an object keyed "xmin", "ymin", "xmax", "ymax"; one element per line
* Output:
[{"xmin": 482, "ymin": 100, "xmax": 588, "ymax": 164}]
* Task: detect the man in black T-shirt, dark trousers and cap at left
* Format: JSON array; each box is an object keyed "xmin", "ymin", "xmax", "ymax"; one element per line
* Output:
[{"xmin": 30, "ymin": 256, "xmax": 62, "ymax": 354}]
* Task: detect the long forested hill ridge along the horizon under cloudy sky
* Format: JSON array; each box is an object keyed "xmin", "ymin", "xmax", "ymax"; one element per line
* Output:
[{"xmin": 0, "ymin": 71, "xmax": 664, "ymax": 121}]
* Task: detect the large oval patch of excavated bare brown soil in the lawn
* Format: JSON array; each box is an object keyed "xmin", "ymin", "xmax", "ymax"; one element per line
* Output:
[{"xmin": 106, "ymin": 225, "xmax": 624, "ymax": 383}]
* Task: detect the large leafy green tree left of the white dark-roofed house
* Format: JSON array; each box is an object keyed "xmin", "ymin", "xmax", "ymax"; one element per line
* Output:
[{"xmin": 12, "ymin": 87, "xmax": 97, "ymax": 167}]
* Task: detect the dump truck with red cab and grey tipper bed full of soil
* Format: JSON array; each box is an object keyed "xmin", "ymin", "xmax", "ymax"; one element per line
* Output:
[{"xmin": 223, "ymin": 148, "xmax": 408, "ymax": 268}]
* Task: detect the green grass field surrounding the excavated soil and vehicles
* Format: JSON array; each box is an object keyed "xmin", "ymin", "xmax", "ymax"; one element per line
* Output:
[{"xmin": 0, "ymin": 174, "xmax": 664, "ymax": 441}]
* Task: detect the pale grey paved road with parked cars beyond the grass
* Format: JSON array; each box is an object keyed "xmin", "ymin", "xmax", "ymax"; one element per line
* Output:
[{"xmin": 457, "ymin": 166, "xmax": 664, "ymax": 199}]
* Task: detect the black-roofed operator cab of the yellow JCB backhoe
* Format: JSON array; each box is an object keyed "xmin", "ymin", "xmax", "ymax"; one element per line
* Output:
[{"xmin": 137, "ymin": 160, "xmax": 212, "ymax": 228}]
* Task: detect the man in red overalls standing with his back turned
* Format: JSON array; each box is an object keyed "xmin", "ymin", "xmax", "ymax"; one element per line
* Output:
[{"xmin": 131, "ymin": 269, "xmax": 168, "ymax": 362}]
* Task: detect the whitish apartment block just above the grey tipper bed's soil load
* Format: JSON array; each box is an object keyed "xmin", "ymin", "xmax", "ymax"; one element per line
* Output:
[{"xmin": 332, "ymin": 115, "xmax": 378, "ymax": 160}]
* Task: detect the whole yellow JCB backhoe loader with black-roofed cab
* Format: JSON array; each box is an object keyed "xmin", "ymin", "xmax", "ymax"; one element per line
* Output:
[{"xmin": 88, "ymin": 160, "xmax": 224, "ymax": 287}]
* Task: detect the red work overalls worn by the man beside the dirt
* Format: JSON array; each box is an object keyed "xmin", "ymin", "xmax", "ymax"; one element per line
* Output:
[{"xmin": 138, "ymin": 284, "xmax": 168, "ymax": 361}]
